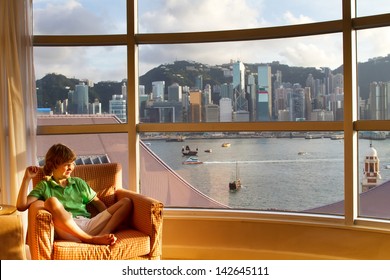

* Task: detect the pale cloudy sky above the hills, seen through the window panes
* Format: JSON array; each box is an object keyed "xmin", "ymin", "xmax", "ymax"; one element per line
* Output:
[{"xmin": 33, "ymin": 0, "xmax": 390, "ymax": 82}]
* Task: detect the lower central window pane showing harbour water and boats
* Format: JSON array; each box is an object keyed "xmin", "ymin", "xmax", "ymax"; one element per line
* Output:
[{"xmin": 141, "ymin": 131, "xmax": 344, "ymax": 212}]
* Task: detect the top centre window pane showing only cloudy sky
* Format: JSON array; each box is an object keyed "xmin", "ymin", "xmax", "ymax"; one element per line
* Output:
[{"xmin": 138, "ymin": 0, "xmax": 341, "ymax": 33}]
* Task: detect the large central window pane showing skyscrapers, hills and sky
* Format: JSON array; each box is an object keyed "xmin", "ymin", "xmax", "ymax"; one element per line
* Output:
[{"xmin": 139, "ymin": 33, "xmax": 344, "ymax": 123}]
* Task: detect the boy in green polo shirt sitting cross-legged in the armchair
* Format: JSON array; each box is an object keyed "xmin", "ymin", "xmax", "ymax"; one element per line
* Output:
[{"xmin": 16, "ymin": 144, "xmax": 132, "ymax": 245}]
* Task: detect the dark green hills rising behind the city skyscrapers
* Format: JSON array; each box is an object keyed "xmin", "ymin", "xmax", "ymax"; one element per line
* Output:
[{"xmin": 36, "ymin": 55, "xmax": 390, "ymax": 112}]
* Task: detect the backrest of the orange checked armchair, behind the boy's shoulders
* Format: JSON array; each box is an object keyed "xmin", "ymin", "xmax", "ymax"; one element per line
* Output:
[{"xmin": 33, "ymin": 163, "xmax": 122, "ymax": 192}]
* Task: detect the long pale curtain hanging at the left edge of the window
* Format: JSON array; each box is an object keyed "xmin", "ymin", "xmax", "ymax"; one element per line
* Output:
[{"xmin": 0, "ymin": 0, "xmax": 36, "ymax": 205}]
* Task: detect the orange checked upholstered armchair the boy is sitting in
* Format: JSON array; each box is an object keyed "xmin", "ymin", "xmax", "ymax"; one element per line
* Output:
[{"xmin": 27, "ymin": 163, "xmax": 163, "ymax": 260}]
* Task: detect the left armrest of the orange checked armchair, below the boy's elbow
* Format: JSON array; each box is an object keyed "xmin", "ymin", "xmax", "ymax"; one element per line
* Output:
[{"xmin": 27, "ymin": 200, "xmax": 54, "ymax": 260}]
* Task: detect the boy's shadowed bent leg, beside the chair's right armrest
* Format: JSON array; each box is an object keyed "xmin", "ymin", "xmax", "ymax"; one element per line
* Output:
[{"xmin": 100, "ymin": 197, "xmax": 132, "ymax": 234}]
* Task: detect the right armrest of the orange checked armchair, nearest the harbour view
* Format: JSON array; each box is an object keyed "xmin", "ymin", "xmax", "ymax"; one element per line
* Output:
[{"xmin": 116, "ymin": 189, "xmax": 164, "ymax": 258}]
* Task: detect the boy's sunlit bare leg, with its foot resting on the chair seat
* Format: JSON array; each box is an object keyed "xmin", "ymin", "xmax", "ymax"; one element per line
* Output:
[{"xmin": 45, "ymin": 197, "xmax": 116, "ymax": 245}]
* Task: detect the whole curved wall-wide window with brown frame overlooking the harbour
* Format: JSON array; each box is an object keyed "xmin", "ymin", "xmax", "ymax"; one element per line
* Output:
[{"xmin": 34, "ymin": 0, "xmax": 390, "ymax": 223}]
